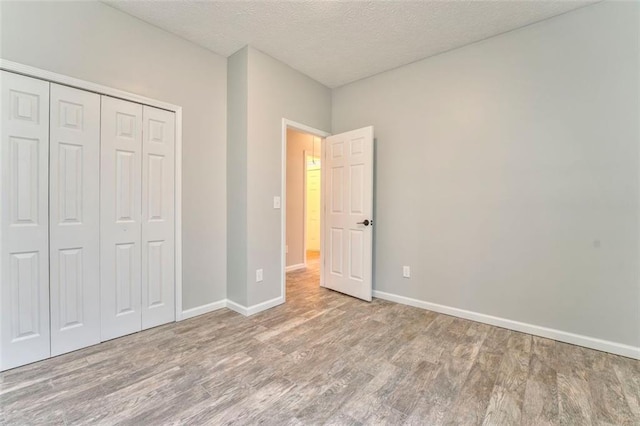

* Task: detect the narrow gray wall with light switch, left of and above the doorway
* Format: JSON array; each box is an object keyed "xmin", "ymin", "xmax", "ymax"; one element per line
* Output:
[{"xmin": 245, "ymin": 47, "xmax": 331, "ymax": 306}]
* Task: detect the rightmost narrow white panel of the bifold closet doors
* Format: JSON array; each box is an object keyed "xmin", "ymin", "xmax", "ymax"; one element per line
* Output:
[{"xmin": 142, "ymin": 105, "xmax": 175, "ymax": 329}]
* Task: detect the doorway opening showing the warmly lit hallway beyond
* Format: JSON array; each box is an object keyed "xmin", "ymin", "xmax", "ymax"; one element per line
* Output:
[{"xmin": 282, "ymin": 120, "xmax": 328, "ymax": 300}]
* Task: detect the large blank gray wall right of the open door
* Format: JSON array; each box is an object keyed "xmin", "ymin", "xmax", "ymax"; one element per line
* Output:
[{"xmin": 332, "ymin": 2, "xmax": 640, "ymax": 346}]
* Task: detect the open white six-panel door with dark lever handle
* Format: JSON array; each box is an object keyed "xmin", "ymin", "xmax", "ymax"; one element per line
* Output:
[{"xmin": 322, "ymin": 127, "xmax": 373, "ymax": 301}]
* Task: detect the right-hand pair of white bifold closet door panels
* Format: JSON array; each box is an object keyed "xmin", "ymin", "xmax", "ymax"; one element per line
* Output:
[{"xmin": 100, "ymin": 96, "xmax": 175, "ymax": 340}]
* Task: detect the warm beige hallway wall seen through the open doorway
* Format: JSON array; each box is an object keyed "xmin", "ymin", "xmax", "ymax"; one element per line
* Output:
[{"xmin": 286, "ymin": 129, "xmax": 322, "ymax": 266}]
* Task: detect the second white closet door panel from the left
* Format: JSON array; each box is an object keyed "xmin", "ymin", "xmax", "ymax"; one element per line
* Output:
[{"xmin": 49, "ymin": 84, "xmax": 100, "ymax": 356}]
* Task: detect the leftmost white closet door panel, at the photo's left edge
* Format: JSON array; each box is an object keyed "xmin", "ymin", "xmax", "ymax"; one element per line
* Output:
[{"xmin": 0, "ymin": 71, "xmax": 50, "ymax": 370}]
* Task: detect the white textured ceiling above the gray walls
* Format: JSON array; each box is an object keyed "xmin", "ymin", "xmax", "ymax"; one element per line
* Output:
[{"xmin": 106, "ymin": 0, "xmax": 594, "ymax": 87}]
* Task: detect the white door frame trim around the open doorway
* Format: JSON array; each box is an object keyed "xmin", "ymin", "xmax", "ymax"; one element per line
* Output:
[{"xmin": 280, "ymin": 118, "xmax": 331, "ymax": 303}]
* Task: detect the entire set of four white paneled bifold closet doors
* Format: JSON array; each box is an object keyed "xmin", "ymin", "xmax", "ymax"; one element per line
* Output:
[{"xmin": 0, "ymin": 71, "xmax": 176, "ymax": 371}]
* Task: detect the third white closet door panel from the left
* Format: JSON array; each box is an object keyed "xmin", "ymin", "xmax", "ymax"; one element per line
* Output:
[{"xmin": 100, "ymin": 96, "xmax": 142, "ymax": 341}]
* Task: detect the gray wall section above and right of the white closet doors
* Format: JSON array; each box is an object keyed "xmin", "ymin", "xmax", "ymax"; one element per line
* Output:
[{"xmin": 0, "ymin": 2, "xmax": 227, "ymax": 309}]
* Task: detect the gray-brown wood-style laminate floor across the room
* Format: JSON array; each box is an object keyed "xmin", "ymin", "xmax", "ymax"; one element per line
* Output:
[{"xmin": 0, "ymin": 251, "xmax": 640, "ymax": 425}]
